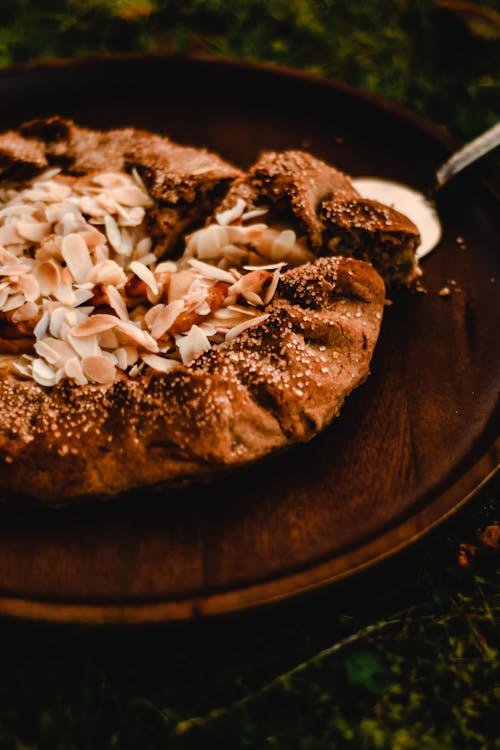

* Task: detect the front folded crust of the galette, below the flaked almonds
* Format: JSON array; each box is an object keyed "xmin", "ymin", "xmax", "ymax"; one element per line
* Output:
[{"xmin": 0, "ymin": 257, "xmax": 385, "ymax": 506}]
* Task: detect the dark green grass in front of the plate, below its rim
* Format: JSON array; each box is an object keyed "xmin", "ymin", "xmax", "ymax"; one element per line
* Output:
[{"xmin": 0, "ymin": 482, "xmax": 500, "ymax": 750}]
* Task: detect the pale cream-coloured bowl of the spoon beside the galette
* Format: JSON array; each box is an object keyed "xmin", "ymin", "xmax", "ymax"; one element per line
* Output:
[{"xmin": 352, "ymin": 177, "xmax": 442, "ymax": 260}]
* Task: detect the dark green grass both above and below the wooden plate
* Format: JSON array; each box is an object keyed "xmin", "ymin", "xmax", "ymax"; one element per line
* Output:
[{"xmin": 0, "ymin": 0, "xmax": 500, "ymax": 750}]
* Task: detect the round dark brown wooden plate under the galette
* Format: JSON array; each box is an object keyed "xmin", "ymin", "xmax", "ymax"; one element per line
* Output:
[{"xmin": 0, "ymin": 57, "xmax": 500, "ymax": 623}]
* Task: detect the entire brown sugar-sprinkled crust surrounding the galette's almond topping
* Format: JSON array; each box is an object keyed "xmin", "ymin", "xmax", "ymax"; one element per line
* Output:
[{"xmin": 0, "ymin": 117, "xmax": 390, "ymax": 506}]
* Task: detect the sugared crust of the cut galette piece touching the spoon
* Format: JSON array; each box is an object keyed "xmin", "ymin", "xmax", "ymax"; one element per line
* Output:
[{"xmin": 217, "ymin": 151, "xmax": 420, "ymax": 287}]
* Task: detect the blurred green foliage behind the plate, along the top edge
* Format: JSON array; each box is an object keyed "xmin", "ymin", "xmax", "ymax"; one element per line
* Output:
[{"xmin": 0, "ymin": 0, "xmax": 500, "ymax": 138}]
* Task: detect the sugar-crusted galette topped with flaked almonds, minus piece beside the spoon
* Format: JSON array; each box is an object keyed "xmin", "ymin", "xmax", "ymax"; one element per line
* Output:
[{"xmin": 0, "ymin": 118, "xmax": 385, "ymax": 506}]
